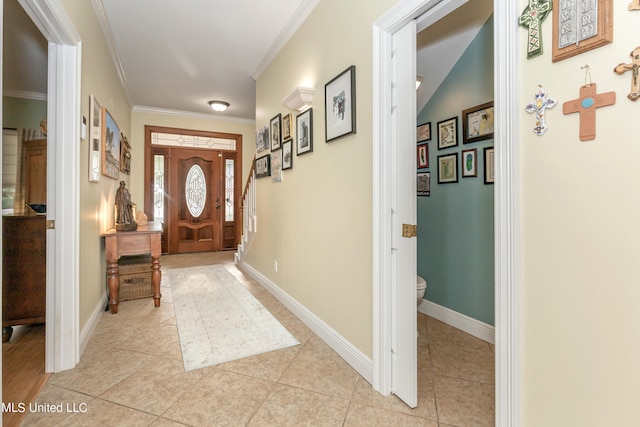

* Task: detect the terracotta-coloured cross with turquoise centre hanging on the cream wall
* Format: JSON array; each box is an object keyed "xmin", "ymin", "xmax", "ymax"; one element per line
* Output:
[{"xmin": 562, "ymin": 83, "xmax": 616, "ymax": 141}]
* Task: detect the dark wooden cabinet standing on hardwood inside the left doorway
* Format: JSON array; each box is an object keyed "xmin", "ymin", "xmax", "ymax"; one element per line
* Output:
[{"xmin": 2, "ymin": 215, "xmax": 47, "ymax": 342}]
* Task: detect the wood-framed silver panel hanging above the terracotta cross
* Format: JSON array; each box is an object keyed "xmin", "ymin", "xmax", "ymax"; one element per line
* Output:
[{"xmin": 551, "ymin": 0, "xmax": 613, "ymax": 62}]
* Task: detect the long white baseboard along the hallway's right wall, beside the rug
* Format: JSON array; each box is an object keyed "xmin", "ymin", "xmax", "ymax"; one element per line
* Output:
[{"xmin": 238, "ymin": 262, "xmax": 373, "ymax": 383}]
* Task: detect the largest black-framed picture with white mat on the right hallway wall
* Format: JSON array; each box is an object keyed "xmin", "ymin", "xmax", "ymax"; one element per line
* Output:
[{"xmin": 324, "ymin": 65, "xmax": 356, "ymax": 142}]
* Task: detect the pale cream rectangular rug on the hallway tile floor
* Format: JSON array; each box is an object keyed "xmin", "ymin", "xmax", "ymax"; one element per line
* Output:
[{"xmin": 166, "ymin": 265, "xmax": 300, "ymax": 371}]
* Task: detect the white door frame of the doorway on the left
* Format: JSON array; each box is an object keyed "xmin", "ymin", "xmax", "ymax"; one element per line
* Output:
[{"xmin": 18, "ymin": 0, "xmax": 82, "ymax": 372}]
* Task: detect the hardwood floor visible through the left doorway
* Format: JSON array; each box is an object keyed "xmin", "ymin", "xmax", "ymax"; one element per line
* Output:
[{"xmin": 2, "ymin": 325, "xmax": 50, "ymax": 427}]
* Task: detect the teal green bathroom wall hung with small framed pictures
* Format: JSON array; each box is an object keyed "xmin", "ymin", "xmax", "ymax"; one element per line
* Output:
[{"xmin": 417, "ymin": 17, "xmax": 495, "ymax": 325}]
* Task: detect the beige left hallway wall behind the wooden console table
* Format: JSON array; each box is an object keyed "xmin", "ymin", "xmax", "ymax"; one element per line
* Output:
[{"xmin": 61, "ymin": 0, "xmax": 131, "ymax": 330}]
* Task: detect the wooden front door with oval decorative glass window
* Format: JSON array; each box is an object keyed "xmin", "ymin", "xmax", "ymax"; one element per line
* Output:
[{"xmin": 167, "ymin": 148, "xmax": 223, "ymax": 254}]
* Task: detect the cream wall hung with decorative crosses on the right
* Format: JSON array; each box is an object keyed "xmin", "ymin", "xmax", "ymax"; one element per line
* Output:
[{"xmin": 519, "ymin": 0, "xmax": 640, "ymax": 427}]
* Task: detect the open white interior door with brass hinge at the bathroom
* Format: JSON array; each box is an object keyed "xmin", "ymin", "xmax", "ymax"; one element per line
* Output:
[{"xmin": 391, "ymin": 20, "xmax": 418, "ymax": 408}]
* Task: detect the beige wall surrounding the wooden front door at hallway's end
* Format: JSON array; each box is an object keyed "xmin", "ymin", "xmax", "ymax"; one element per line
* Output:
[{"xmin": 129, "ymin": 110, "xmax": 256, "ymax": 205}]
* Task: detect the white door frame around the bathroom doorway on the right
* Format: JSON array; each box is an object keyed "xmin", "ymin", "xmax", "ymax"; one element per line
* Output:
[{"xmin": 373, "ymin": 0, "xmax": 521, "ymax": 426}]
